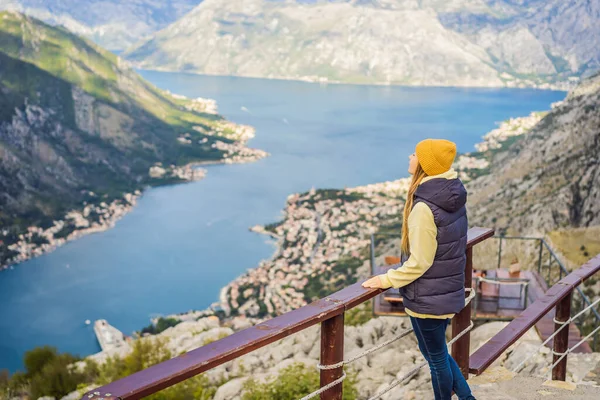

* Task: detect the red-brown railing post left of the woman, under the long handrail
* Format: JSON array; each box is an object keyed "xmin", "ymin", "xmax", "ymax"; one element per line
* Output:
[{"xmin": 320, "ymin": 313, "xmax": 344, "ymax": 400}]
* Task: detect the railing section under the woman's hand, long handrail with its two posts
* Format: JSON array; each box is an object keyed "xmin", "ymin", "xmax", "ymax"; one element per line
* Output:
[{"xmin": 82, "ymin": 228, "xmax": 494, "ymax": 400}]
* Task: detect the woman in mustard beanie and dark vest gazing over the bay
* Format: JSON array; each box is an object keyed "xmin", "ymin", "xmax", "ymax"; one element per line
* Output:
[{"xmin": 363, "ymin": 139, "xmax": 475, "ymax": 400}]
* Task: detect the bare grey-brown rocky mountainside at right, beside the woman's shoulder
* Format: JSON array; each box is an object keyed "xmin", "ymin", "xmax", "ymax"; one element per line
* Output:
[{"xmin": 468, "ymin": 74, "xmax": 600, "ymax": 235}]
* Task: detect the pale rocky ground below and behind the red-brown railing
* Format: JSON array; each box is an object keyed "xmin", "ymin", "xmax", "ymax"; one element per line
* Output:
[{"xmin": 68, "ymin": 317, "xmax": 600, "ymax": 400}]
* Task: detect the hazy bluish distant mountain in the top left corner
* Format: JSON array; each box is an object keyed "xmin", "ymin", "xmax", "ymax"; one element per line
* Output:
[{"xmin": 0, "ymin": 0, "xmax": 202, "ymax": 51}]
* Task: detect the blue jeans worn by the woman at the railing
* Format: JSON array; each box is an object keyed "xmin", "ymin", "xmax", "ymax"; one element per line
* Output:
[{"xmin": 410, "ymin": 317, "xmax": 475, "ymax": 400}]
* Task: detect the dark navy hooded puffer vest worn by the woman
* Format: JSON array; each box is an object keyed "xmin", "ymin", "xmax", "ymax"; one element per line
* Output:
[{"xmin": 400, "ymin": 178, "xmax": 468, "ymax": 315}]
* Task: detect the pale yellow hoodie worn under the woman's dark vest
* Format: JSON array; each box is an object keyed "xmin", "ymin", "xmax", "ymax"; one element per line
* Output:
[{"xmin": 379, "ymin": 169, "xmax": 458, "ymax": 319}]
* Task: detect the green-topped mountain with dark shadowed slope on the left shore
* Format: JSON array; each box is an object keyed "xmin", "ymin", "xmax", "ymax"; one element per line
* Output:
[{"xmin": 0, "ymin": 12, "xmax": 262, "ymax": 266}]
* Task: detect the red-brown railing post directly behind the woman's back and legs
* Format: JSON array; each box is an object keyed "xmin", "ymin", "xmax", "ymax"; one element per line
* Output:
[{"xmin": 452, "ymin": 248, "xmax": 473, "ymax": 379}]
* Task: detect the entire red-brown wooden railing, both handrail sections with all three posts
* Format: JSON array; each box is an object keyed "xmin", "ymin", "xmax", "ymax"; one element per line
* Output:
[{"xmin": 82, "ymin": 228, "xmax": 600, "ymax": 400}]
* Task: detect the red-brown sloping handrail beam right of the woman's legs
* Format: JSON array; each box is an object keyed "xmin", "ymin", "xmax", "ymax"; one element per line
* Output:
[{"xmin": 469, "ymin": 255, "xmax": 600, "ymax": 375}]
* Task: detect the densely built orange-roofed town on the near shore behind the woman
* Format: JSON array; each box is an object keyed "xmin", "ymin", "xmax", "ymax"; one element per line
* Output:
[{"xmin": 218, "ymin": 113, "xmax": 545, "ymax": 318}]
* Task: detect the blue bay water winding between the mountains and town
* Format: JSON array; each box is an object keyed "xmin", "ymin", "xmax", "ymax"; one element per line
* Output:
[{"xmin": 0, "ymin": 71, "xmax": 564, "ymax": 371}]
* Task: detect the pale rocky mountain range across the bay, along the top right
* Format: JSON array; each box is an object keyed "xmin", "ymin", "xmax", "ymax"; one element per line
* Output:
[{"xmin": 126, "ymin": 0, "xmax": 600, "ymax": 88}]
